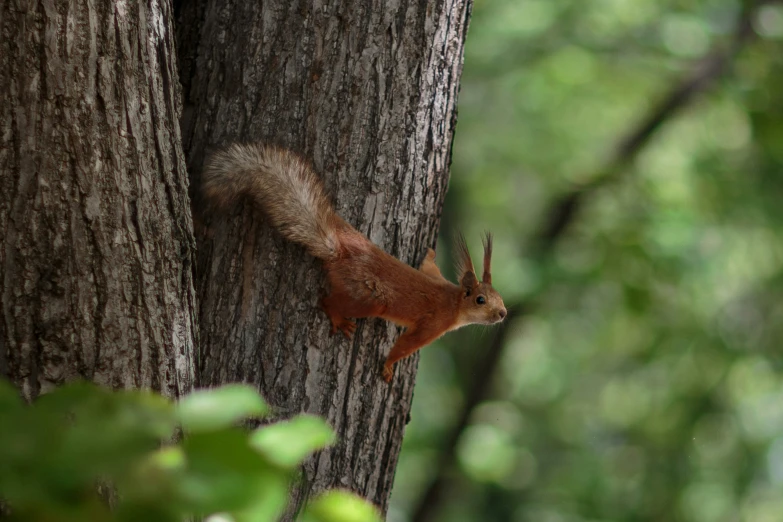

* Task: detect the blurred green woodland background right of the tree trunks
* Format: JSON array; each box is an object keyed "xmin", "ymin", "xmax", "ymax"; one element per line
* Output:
[{"xmin": 388, "ymin": 0, "xmax": 783, "ymax": 522}]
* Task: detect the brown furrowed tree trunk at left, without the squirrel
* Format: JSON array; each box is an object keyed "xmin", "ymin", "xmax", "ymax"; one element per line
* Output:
[{"xmin": 0, "ymin": 0, "xmax": 196, "ymax": 399}]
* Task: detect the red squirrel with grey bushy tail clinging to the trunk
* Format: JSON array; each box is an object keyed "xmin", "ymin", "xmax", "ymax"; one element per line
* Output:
[{"xmin": 202, "ymin": 144, "xmax": 506, "ymax": 382}]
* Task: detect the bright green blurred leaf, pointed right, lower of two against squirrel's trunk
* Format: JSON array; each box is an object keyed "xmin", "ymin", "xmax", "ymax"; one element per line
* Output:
[{"xmin": 250, "ymin": 415, "xmax": 335, "ymax": 469}]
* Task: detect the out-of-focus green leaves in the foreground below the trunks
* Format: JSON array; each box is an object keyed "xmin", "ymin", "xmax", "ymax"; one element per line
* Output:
[{"xmin": 0, "ymin": 381, "xmax": 380, "ymax": 522}]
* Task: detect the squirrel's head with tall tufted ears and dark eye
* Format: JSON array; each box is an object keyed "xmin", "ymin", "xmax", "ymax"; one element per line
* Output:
[{"xmin": 456, "ymin": 232, "xmax": 507, "ymax": 326}]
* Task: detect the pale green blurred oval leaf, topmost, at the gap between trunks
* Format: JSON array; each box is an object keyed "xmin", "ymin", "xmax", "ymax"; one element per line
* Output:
[{"xmin": 177, "ymin": 384, "xmax": 268, "ymax": 432}]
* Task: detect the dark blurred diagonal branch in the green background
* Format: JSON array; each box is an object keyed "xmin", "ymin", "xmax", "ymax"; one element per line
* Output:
[{"xmin": 411, "ymin": 2, "xmax": 764, "ymax": 522}]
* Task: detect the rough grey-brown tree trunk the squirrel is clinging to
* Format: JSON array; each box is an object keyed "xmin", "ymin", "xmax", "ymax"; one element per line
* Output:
[{"xmin": 178, "ymin": 0, "xmax": 471, "ymax": 511}]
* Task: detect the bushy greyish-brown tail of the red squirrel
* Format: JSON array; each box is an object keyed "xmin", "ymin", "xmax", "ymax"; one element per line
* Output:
[{"xmin": 202, "ymin": 144, "xmax": 344, "ymax": 260}]
